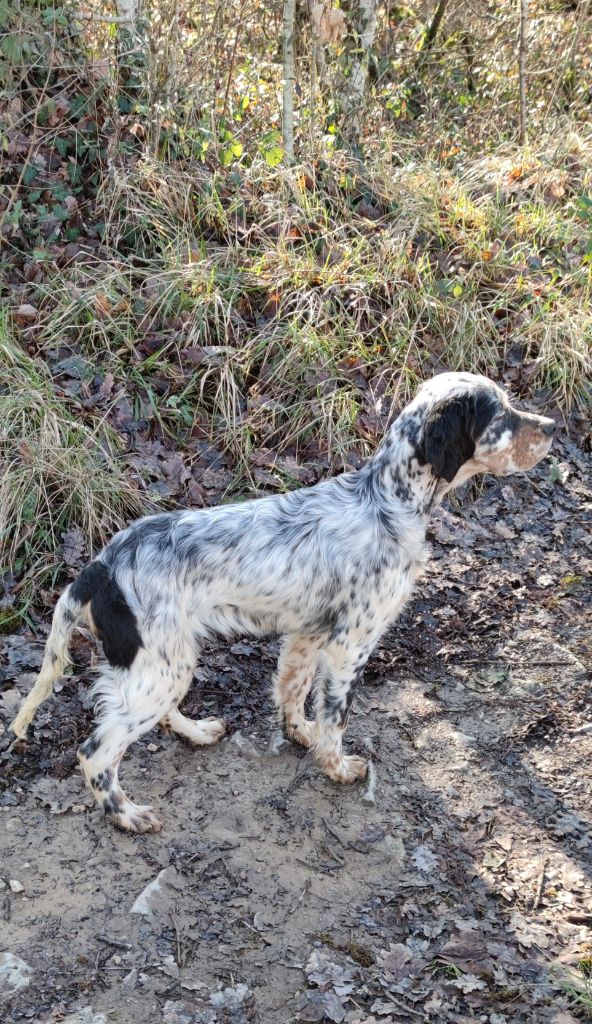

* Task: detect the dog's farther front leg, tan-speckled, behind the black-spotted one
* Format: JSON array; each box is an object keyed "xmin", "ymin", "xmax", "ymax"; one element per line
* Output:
[{"xmin": 273, "ymin": 635, "xmax": 324, "ymax": 746}]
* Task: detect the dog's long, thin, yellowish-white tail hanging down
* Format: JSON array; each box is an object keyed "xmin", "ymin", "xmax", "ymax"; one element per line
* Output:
[{"xmin": 10, "ymin": 586, "xmax": 82, "ymax": 739}]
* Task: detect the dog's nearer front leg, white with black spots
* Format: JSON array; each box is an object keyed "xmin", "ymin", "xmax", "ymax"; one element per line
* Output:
[{"xmin": 313, "ymin": 630, "xmax": 375, "ymax": 782}]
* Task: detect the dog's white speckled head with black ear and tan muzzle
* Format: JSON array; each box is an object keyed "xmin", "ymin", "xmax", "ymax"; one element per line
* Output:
[{"xmin": 413, "ymin": 373, "xmax": 556, "ymax": 490}]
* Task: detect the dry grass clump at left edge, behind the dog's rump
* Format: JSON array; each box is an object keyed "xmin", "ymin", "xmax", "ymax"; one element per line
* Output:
[{"xmin": 0, "ymin": 322, "xmax": 145, "ymax": 601}]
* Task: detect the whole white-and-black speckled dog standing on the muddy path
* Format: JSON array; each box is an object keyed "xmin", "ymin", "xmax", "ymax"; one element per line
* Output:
[{"xmin": 11, "ymin": 373, "xmax": 555, "ymax": 833}]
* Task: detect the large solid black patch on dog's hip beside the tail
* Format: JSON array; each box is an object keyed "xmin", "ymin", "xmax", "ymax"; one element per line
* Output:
[{"xmin": 70, "ymin": 562, "xmax": 143, "ymax": 669}]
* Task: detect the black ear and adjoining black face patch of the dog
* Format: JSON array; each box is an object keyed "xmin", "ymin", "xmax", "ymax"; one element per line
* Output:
[{"xmin": 422, "ymin": 390, "xmax": 498, "ymax": 483}]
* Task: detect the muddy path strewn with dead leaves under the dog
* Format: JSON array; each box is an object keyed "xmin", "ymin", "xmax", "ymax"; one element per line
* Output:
[{"xmin": 0, "ymin": 438, "xmax": 592, "ymax": 1024}]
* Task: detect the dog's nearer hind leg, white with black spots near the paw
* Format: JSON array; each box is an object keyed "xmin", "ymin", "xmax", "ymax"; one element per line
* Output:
[{"xmin": 78, "ymin": 650, "xmax": 186, "ymax": 833}]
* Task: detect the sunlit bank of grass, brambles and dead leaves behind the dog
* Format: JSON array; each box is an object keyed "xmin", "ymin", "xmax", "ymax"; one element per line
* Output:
[{"xmin": 0, "ymin": 0, "xmax": 592, "ymax": 606}]
